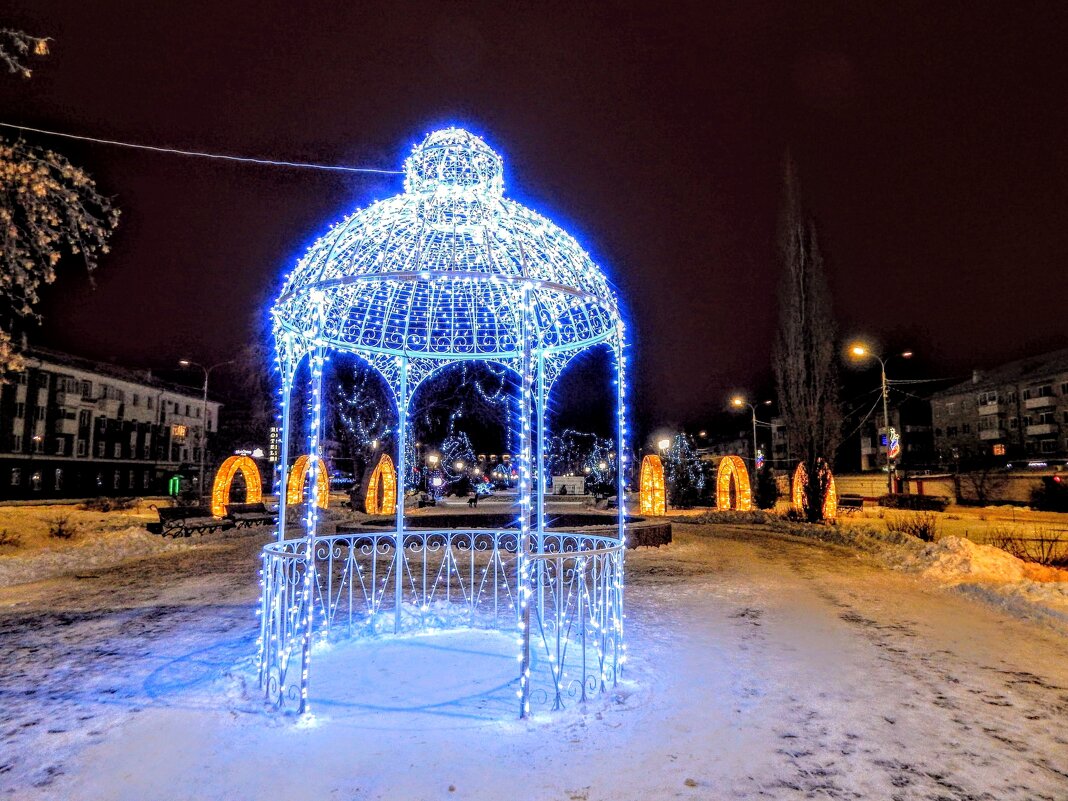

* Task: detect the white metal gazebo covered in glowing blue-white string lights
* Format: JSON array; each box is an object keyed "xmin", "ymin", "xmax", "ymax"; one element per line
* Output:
[{"xmin": 260, "ymin": 128, "xmax": 627, "ymax": 716}]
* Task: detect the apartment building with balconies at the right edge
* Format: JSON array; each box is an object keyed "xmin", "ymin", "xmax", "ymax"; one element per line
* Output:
[{"xmin": 931, "ymin": 348, "xmax": 1068, "ymax": 466}]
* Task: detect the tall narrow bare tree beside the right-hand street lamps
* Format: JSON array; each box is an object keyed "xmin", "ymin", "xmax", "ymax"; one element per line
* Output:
[{"xmin": 773, "ymin": 157, "xmax": 842, "ymax": 522}]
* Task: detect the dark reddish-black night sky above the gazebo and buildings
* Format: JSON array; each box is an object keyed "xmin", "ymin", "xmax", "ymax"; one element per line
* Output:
[{"xmin": 0, "ymin": 0, "xmax": 1068, "ymax": 440}]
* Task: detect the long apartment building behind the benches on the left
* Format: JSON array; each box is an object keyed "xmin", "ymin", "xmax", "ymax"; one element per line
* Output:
[{"xmin": 0, "ymin": 350, "xmax": 220, "ymax": 499}]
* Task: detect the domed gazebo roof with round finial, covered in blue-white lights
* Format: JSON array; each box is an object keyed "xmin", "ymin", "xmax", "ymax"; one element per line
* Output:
[{"xmin": 272, "ymin": 128, "xmax": 621, "ymax": 360}]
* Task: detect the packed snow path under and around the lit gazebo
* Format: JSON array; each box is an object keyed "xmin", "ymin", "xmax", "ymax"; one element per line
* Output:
[{"xmin": 0, "ymin": 525, "xmax": 1068, "ymax": 801}]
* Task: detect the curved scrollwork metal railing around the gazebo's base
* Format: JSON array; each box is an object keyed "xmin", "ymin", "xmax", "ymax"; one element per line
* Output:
[{"xmin": 260, "ymin": 530, "xmax": 624, "ymax": 713}]
